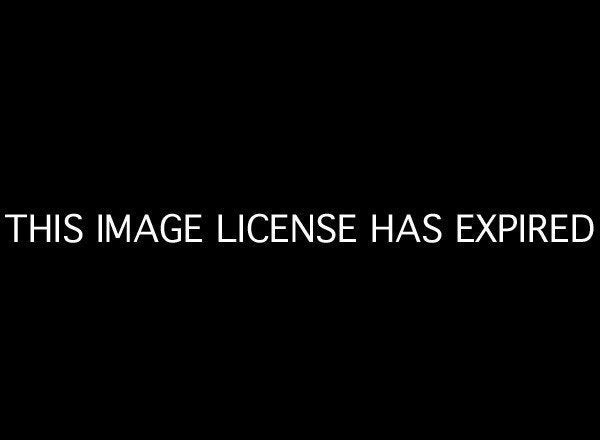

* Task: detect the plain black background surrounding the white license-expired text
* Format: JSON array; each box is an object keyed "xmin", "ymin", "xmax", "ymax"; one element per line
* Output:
[{"xmin": 1, "ymin": 5, "xmax": 598, "ymax": 433}]
